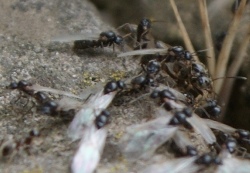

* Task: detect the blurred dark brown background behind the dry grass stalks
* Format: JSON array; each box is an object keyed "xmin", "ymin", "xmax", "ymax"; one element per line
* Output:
[{"xmin": 90, "ymin": 0, "xmax": 250, "ymax": 130}]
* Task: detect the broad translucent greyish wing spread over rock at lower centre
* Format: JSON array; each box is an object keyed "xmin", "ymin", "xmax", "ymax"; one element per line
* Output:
[{"xmin": 120, "ymin": 109, "xmax": 178, "ymax": 161}]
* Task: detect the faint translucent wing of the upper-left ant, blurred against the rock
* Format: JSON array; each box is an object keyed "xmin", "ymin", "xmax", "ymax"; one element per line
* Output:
[{"xmin": 51, "ymin": 33, "xmax": 100, "ymax": 42}]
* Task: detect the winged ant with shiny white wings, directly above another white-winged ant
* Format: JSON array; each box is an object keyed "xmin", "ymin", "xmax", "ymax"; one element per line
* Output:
[{"xmin": 68, "ymin": 81, "xmax": 125, "ymax": 140}]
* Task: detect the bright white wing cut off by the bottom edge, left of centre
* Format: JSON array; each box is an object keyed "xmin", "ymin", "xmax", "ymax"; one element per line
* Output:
[{"xmin": 71, "ymin": 126, "xmax": 107, "ymax": 173}]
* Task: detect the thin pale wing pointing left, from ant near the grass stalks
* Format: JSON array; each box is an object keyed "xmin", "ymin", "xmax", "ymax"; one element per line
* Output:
[{"xmin": 118, "ymin": 49, "xmax": 168, "ymax": 57}]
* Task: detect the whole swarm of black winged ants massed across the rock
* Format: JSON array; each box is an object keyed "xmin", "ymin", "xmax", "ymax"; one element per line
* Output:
[{"xmin": 5, "ymin": 13, "xmax": 250, "ymax": 173}]
